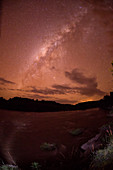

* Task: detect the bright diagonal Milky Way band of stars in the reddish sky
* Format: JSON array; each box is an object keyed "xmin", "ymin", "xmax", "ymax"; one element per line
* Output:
[{"xmin": 23, "ymin": 4, "xmax": 87, "ymax": 87}]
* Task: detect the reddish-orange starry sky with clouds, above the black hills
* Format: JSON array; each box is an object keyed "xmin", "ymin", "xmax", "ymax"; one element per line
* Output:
[{"xmin": 0, "ymin": 0, "xmax": 113, "ymax": 104}]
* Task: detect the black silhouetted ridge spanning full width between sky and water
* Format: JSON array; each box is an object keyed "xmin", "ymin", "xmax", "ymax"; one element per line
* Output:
[{"xmin": 0, "ymin": 92, "xmax": 113, "ymax": 112}]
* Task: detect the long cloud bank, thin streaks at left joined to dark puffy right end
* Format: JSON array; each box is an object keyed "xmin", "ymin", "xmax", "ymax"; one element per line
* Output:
[{"xmin": 7, "ymin": 73, "xmax": 105, "ymax": 99}]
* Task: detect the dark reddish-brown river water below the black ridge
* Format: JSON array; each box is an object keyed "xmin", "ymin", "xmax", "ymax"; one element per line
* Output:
[{"xmin": 0, "ymin": 108, "xmax": 108, "ymax": 167}]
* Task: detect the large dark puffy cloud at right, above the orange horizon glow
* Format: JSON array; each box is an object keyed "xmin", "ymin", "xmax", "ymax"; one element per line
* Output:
[{"xmin": 65, "ymin": 68, "xmax": 105, "ymax": 96}]
